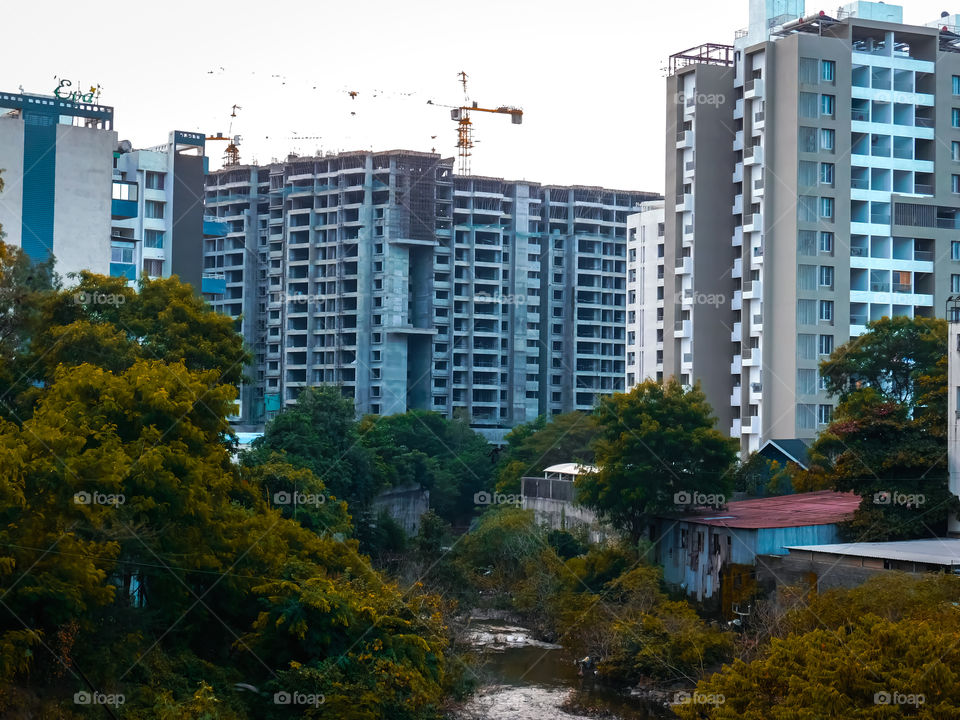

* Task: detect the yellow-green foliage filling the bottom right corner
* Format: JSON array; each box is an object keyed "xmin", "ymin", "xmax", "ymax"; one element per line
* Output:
[{"xmin": 674, "ymin": 573, "xmax": 960, "ymax": 720}]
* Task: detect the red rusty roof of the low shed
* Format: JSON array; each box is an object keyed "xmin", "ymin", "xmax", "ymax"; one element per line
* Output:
[{"xmin": 680, "ymin": 490, "xmax": 860, "ymax": 530}]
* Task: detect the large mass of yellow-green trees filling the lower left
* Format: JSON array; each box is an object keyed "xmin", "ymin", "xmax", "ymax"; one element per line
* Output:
[{"xmin": 0, "ymin": 248, "xmax": 460, "ymax": 720}]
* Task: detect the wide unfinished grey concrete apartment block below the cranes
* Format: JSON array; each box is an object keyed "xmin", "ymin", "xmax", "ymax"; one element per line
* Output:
[{"xmin": 204, "ymin": 150, "xmax": 656, "ymax": 438}]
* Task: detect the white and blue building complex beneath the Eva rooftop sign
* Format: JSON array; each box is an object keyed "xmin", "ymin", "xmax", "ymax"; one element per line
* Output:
[{"xmin": 0, "ymin": 88, "xmax": 222, "ymax": 289}]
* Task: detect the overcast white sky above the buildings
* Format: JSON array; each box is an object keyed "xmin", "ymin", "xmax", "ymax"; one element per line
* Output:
[{"xmin": 9, "ymin": 0, "xmax": 960, "ymax": 191}]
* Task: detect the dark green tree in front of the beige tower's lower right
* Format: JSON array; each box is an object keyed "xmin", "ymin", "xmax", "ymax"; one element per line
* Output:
[{"xmin": 795, "ymin": 317, "xmax": 956, "ymax": 540}]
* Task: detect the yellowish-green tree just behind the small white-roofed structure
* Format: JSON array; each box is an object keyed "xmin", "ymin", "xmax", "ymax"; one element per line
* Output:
[{"xmin": 496, "ymin": 411, "xmax": 598, "ymax": 494}]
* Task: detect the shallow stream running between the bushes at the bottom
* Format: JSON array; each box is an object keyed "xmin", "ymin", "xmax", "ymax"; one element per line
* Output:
[{"xmin": 454, "ymin": 620, "xmax": 674, "ymax": 720}]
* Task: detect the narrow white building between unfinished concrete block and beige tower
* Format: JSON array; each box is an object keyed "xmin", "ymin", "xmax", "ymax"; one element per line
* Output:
[{"xmin": 625, "ymin": 200, "xmax": 664, "ymax": 390}]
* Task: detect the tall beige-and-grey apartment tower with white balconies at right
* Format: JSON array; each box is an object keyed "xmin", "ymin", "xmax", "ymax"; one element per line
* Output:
[{"xmin": 664, "ymin": 0, "xmax": 960, "ymax": 453}]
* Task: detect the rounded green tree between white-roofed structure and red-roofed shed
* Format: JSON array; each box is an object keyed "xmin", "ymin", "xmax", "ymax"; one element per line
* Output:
[{"xmin": 576, "ymin": 379, "xmax": 737, "ymax": 540}]
